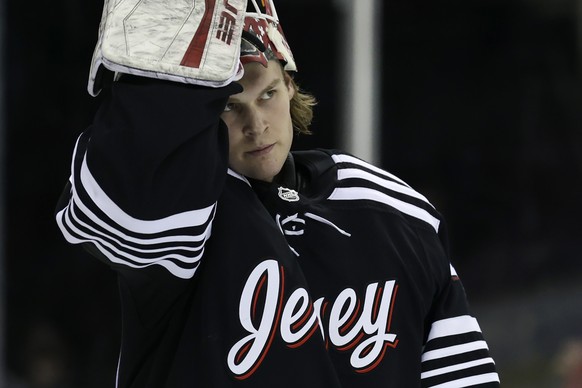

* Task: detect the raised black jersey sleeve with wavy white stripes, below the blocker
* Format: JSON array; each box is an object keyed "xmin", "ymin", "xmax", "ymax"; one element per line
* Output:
[{"xmin": 56, "ymin": 76, "xmax": 239, "ymax": 279}]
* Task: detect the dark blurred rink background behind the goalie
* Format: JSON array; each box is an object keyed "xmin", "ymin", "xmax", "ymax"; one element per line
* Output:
[{"xmin": 0, "ymin": 0, "xmax": 582, "ymax": 388}]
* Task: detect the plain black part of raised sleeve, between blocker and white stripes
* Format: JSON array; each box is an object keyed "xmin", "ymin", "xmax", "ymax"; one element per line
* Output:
[{"xmin": 86, "ymin": 80, "xmax": 240, "ymax": 219}]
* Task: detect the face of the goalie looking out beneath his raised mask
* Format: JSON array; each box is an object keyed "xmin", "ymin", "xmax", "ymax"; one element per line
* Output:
[{"xmin": 221, "ymin": 61, "xmax": 295, "ymax": 182}]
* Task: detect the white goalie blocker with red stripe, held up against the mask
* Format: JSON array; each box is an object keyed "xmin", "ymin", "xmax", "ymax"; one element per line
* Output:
[{"xmin": 87, "ymin": 0, "xmax": 247, "ymax": 96}]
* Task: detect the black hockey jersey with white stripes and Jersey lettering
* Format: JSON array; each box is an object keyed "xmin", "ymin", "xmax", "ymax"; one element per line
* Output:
[{"xmin": 57, "ymin": 77, "xmax": 498, "ymax": 388}]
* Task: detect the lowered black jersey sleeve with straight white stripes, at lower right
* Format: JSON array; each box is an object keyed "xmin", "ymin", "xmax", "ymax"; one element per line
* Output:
[{"xmin": 421, "ymin": 223, "xmax": 499, "ymax": 388}]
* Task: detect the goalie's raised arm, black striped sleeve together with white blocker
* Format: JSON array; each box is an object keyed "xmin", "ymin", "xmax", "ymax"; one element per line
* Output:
[{"xmin": 57, "ymin": 0, "xmax": 251, "ymax": 279}]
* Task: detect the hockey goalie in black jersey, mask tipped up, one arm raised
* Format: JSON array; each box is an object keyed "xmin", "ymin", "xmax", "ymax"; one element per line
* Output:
[{"xmin": 57, "ymin": 0, "xmax": 498, "ymax": 387}]
